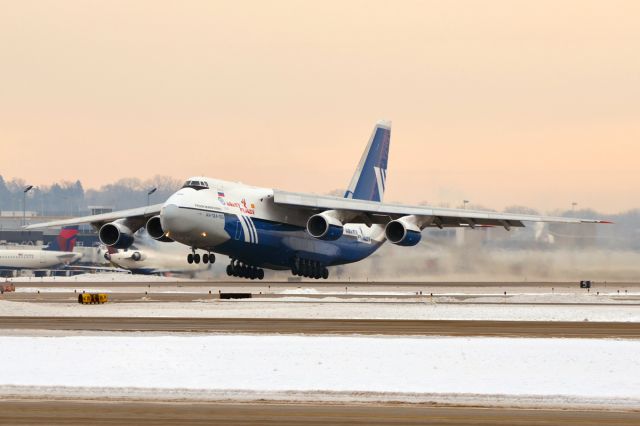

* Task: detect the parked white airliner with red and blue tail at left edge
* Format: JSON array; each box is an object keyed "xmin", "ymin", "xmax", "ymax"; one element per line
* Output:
[{"xmin": 0, "ymin": 226, "xmax": 82, "ymax": 270}]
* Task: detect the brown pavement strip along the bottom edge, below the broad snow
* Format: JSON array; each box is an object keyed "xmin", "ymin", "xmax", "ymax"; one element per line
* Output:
[{"xmin": 0, "ymin": 400, "xmax": 640, "ymax": 426}]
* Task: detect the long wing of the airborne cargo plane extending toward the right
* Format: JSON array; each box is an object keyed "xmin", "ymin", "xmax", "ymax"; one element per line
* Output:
[{"xmin": 273, "ymin": 190, "xmax": 610, "ymax": 229}]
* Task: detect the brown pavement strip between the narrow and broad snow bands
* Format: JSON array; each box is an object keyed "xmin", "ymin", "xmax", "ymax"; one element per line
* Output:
[{"xmin": 0, "ymin": 316, "xmax": 640, "ymax": 339}]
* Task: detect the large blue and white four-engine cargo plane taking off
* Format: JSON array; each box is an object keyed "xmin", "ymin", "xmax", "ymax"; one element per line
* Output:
[{"xmin": 27, "ymin": 121, "xmax": 604, "ymax": 279}]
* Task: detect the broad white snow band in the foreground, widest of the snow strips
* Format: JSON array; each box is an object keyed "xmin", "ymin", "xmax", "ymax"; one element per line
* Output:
[{"xmin": 0, "ymin": 333, "xmax": 640, "ymax": 404}]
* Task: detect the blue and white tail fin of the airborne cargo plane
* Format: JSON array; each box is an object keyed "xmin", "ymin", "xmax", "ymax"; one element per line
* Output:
[{"xmin": 344, "ymin": 121, "xmax": 391, "ymax": 201}]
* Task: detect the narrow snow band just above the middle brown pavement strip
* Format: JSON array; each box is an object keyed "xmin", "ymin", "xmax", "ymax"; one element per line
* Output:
[{"xmin": 0, "ymin": 295, "xmax": 640, "ymax": 322}]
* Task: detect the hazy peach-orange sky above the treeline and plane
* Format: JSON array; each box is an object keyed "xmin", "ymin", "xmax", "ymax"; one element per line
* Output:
[{"xmin": 0, "ymin": 0, "xmax": 640, "ymax": 212}]
